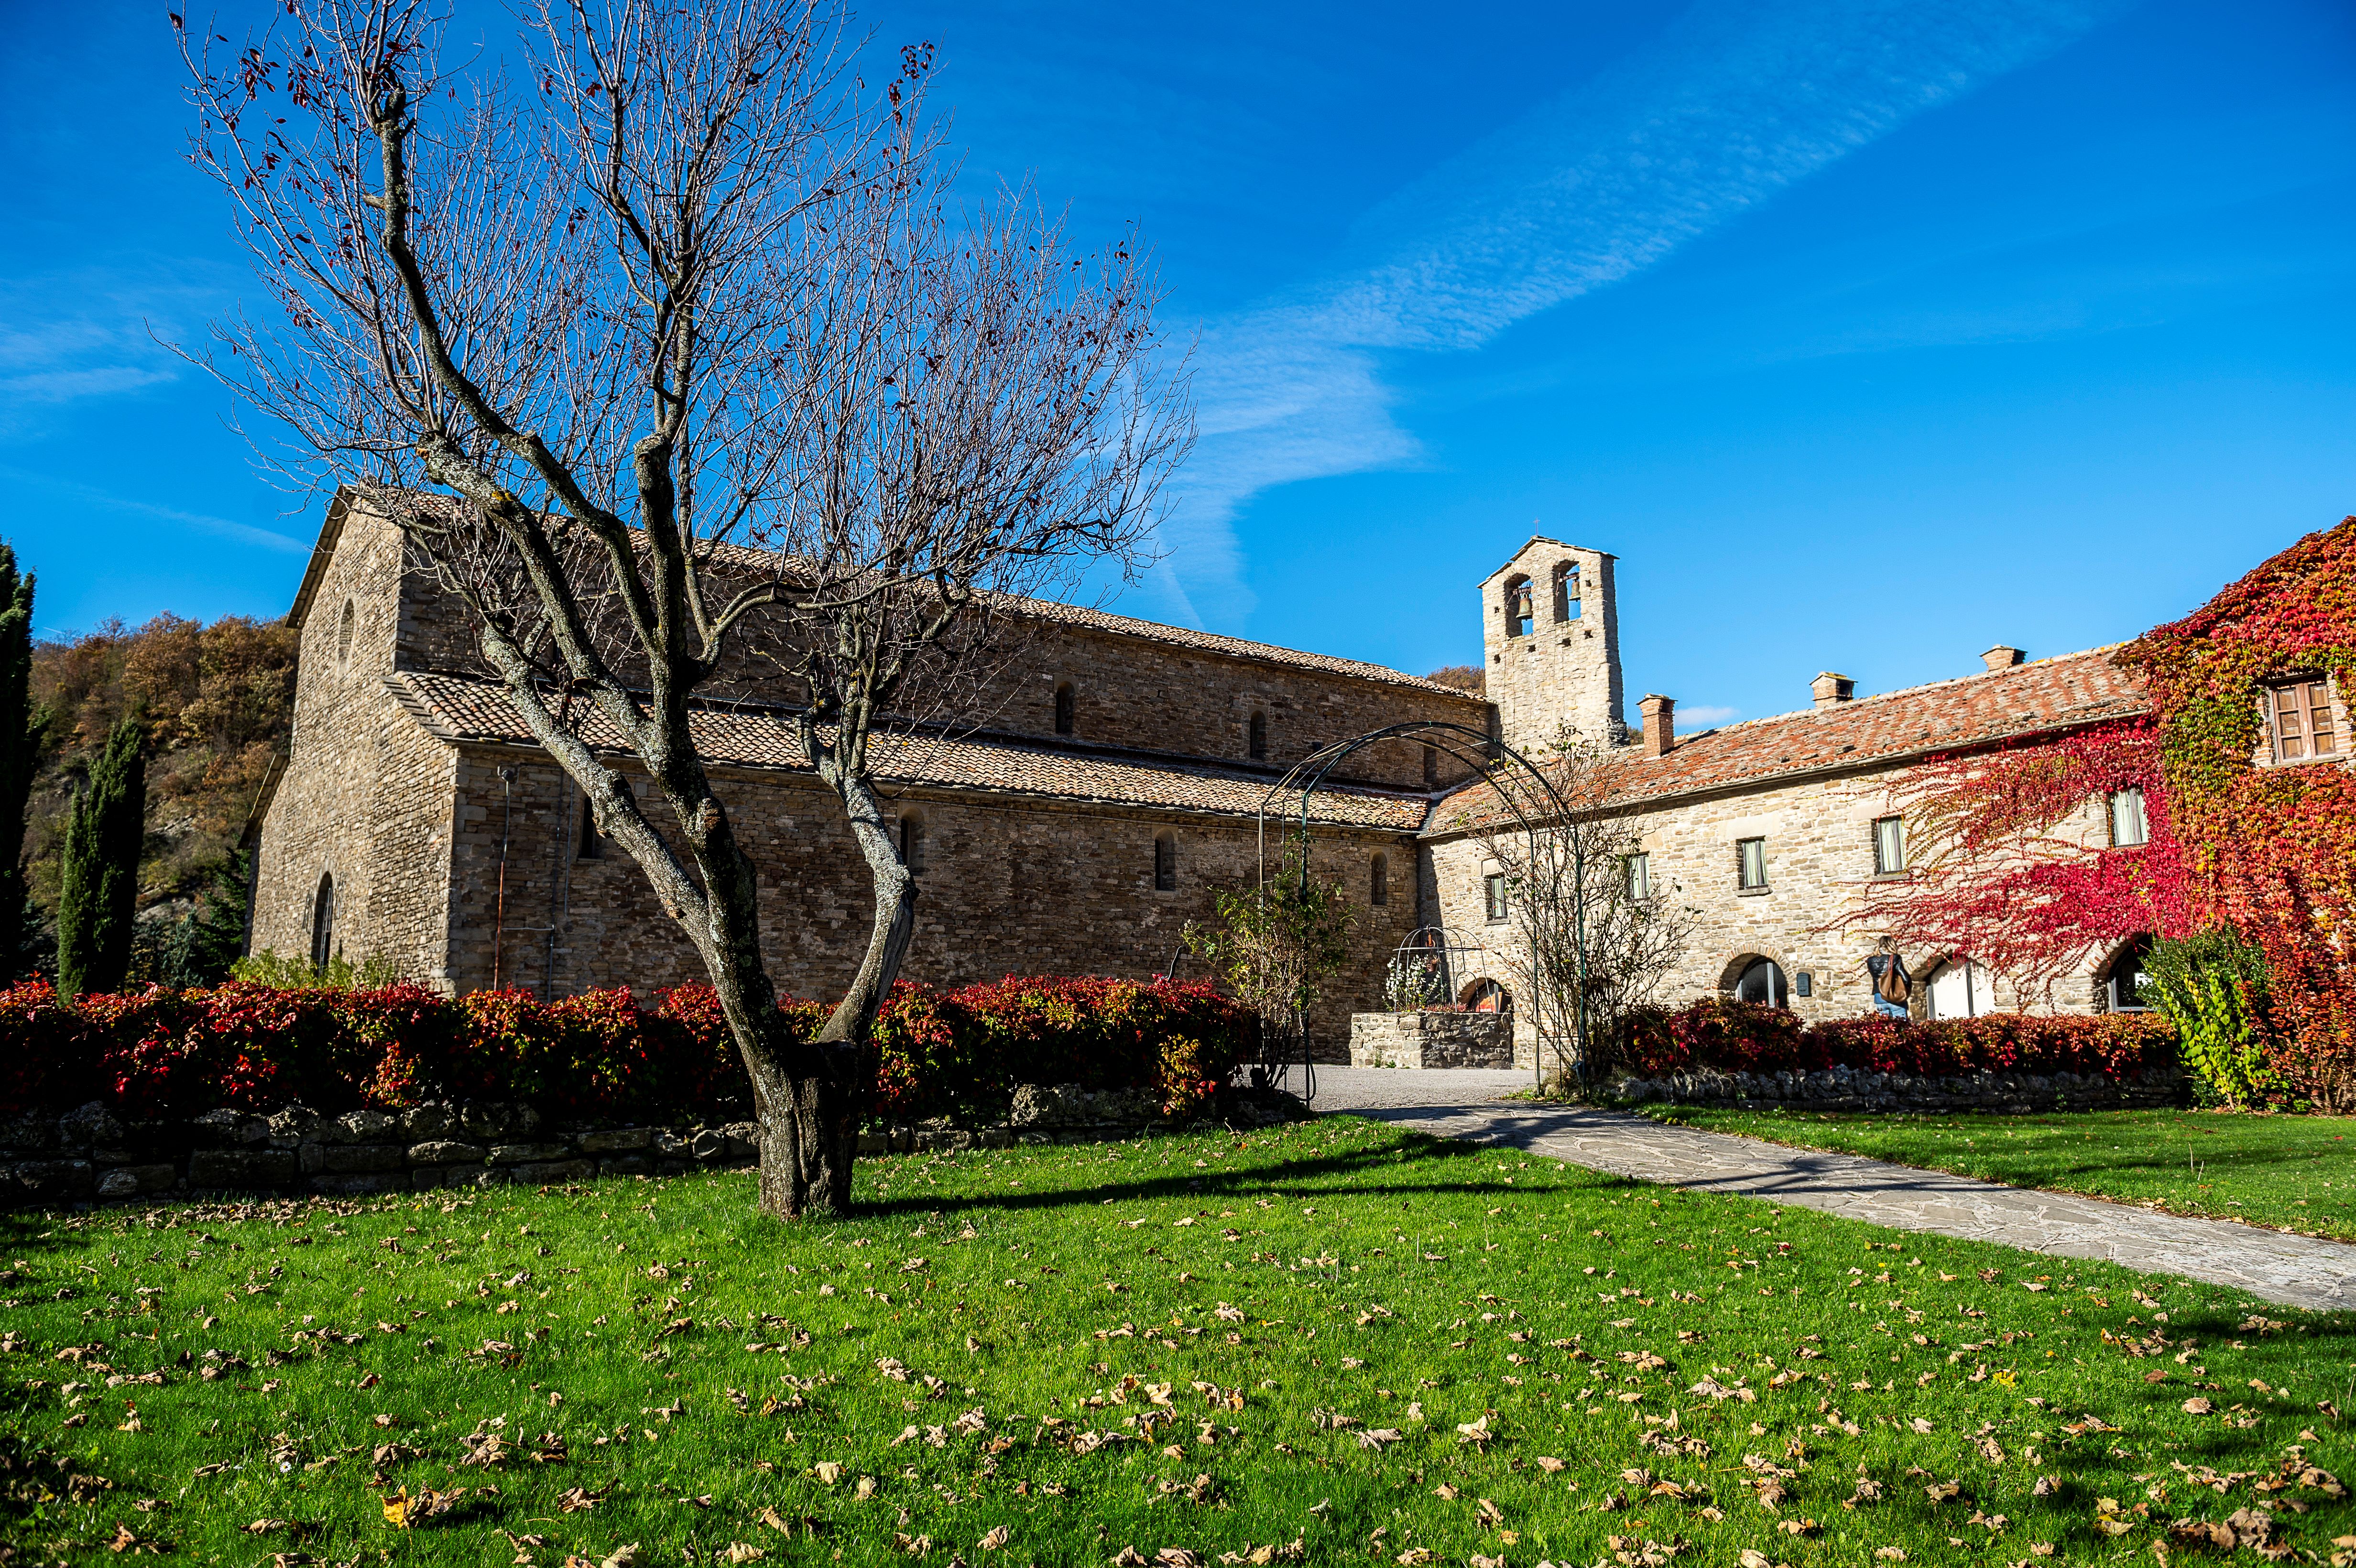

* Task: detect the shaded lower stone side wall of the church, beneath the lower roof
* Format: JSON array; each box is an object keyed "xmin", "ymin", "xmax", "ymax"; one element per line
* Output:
[{"xmin": 447, "ymin": 746, "xmax": 1416, "ymax": 1059}]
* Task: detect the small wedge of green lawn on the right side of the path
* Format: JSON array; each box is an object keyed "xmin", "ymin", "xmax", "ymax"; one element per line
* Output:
[{"xmin": 1642, "ymin": 1104, "xmax": 2356, "ymax": 1241}]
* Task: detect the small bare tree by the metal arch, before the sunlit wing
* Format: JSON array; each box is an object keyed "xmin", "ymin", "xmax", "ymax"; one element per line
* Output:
[{"xmin": 1482, "ymin": 725, "xmax": 1696, "ymax": 1085}]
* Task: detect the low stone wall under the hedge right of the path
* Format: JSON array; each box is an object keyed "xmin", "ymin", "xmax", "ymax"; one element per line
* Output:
[{"xmin": 1604, "ymin": 1067, "xmax": 2191, "ymax": 1113}]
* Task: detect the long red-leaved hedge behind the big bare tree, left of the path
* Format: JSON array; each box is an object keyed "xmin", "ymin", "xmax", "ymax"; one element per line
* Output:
[{"xmin": 0, "ymin": 977, "xmax": 1251, "ymax": 1121}]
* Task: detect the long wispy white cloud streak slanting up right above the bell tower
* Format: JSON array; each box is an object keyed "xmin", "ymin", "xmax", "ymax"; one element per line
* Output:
[{"xmin": 1168, "ymin": 0, "xmax": 2127, "ymax": 619}]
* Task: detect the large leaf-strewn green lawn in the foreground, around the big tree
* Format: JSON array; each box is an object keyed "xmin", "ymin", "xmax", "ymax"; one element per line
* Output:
[{"xmin": 0, "ymin": 1118, "xmax": 2356, "ymax": 1568}]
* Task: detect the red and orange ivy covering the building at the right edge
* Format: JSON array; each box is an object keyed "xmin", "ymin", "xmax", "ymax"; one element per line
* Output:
[{"xmin": 2118, "ymin": 518, "xmax": 2356, "ymax": 1109}]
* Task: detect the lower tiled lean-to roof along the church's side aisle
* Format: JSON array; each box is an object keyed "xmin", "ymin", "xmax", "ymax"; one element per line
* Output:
[{"xmin": 386, "ymin": 671, "xmax": 1430, "ymax": 833}]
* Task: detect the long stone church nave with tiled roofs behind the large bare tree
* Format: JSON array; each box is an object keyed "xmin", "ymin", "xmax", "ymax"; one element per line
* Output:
[{"xmin": 252, "ymin": 504, "xmax": 1489, "ymax": 1035}]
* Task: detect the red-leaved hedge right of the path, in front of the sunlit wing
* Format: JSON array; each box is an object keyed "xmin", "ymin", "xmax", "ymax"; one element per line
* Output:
[{"xmin": 1621, "ymin": 998, "xmax": 2177, "ymax": 1078}]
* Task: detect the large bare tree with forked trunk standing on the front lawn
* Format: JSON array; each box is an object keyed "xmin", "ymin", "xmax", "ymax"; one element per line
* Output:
[{"xmin": 184, "ymin": 0, "xmax": 1185, "ymax": 1215}]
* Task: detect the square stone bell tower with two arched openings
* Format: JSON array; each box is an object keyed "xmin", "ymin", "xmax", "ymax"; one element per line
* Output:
[{"xmin": 1480, "ymin": 534, "xmax": 1625, "ymax": 753}]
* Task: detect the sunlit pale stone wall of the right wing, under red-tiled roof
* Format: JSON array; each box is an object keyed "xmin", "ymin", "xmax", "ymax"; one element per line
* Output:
[{"xmin": 1423, "ymin": 753, "xmax": 2104, "ymax": 1031}]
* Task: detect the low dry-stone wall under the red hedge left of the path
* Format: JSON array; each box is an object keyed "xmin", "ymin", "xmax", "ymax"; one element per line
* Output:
[{"xmin": 0, "ymin": 1085, "xmax": 1303, "ymax": 1206}]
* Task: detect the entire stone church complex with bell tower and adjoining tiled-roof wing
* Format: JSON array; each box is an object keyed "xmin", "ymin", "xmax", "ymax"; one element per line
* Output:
[{"xmin": 250, "ymin": 497, "xmax": 2177, "ymax": 1055}]
